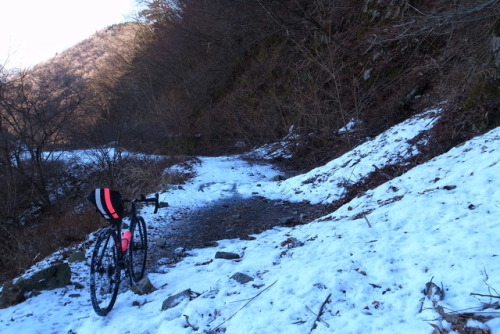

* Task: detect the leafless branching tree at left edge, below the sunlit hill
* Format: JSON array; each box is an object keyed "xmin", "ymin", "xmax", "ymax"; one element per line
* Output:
[{"xmin": 0, "ymin": 72, "xmax": 81, "ymax": 207}]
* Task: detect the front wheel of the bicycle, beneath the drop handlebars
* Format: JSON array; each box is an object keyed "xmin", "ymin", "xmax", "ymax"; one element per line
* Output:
[{"xmin": 128, "ymin": 217, "xmax": 148, "ymax": 284}]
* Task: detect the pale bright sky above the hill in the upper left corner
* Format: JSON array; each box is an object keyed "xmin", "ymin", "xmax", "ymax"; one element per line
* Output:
[{"xmin": 0, "ymin": 0, "xmax": 141, "ymax": 68}]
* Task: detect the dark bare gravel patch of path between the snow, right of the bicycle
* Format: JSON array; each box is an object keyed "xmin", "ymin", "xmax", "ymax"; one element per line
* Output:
[{"xmin": 150, "ymin": 196, "xmax": 328, "ymax": 271}]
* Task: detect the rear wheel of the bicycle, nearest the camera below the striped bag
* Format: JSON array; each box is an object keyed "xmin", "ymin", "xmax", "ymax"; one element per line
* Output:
[{"xmin": 90, "ymin": 227, "xmax": 121, "ymax": 316}]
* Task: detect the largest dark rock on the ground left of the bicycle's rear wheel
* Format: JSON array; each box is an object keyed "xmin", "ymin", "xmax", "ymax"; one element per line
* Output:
[{"xmin": 16, "ymin": 263, "xmax": 71, "ymax": 292}]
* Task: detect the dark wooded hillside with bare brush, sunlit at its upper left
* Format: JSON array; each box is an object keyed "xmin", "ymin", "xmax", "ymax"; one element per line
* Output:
[{"xmin": 13, "ymin": 0, "xmax": 500, "ymax": 160}]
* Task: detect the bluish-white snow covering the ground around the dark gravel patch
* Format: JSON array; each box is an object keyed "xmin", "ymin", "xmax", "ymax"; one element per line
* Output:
[{"xmin": 0, "ymin": 110, "xmax": 500, "ymax": 334}]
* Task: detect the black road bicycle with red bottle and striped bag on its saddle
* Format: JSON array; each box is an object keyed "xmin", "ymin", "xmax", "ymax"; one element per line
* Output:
[{"xmin": 88, "ymin": 188, "xmax": 159, "ymax": 316}]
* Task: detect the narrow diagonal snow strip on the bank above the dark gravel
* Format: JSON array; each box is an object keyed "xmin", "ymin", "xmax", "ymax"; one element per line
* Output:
[{"xmin": 242, "ymin": 109, "xmax": 440, "ymax": 204}]
